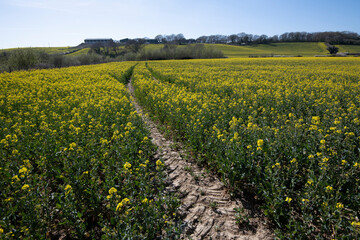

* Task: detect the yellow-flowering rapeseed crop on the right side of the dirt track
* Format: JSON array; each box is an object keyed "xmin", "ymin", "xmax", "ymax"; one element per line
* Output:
[{"xmin": 133, "ymin": 58, "xmax": 360, "ymax": 239}]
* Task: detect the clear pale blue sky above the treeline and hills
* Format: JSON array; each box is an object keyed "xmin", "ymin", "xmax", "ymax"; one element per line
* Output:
[{"xmin": 0, "ymin": 0, "xmax": 360, "ymax": 49}]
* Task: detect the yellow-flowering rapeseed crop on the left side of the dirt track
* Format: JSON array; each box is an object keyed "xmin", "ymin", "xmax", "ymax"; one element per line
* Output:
[{"xmin": 0, "ymin": 63, "xmax": 178, "ymax": 239}]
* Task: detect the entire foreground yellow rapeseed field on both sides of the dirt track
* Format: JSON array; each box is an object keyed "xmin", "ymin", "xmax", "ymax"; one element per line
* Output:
[{"xmin": 0, "ymin": 57, "xmax": 360, "ymax": 239}]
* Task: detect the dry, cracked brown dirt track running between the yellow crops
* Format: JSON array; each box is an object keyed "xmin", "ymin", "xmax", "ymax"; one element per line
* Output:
[{"xmin": 127, "ymin": 79, "xmax": 273, "ymax": 240}]
